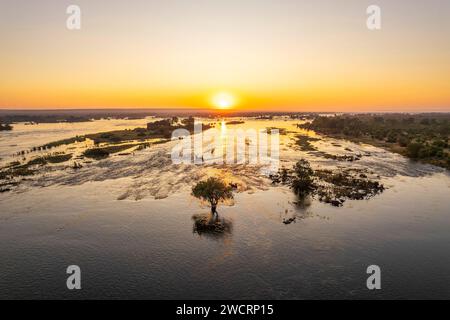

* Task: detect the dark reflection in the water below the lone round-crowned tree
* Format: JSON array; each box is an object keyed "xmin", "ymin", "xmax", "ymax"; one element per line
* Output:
[{"xmin": 192, "ymin": 213, "xmax": 233, "ymax": 239}]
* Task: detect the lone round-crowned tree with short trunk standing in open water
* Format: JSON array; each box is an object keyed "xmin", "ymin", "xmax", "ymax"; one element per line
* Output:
[{"xmin": 192, "ymin": 177, "xmax": 233, "ymax": 214}]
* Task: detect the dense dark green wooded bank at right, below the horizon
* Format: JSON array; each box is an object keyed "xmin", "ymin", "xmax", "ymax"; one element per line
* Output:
[{"xmin": 301, "ymin": 113, "xmax": 450, "ymax": 169}]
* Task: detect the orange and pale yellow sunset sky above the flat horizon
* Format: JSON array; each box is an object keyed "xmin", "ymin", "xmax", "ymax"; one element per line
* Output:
[{"xmin": 0, "ymin": 0, "xmax": 450, "ymax": 112}]
